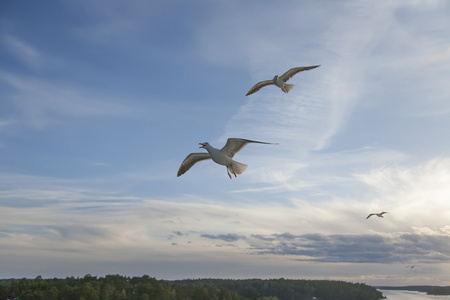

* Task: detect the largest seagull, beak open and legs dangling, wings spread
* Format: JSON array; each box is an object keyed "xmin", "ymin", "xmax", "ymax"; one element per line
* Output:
[{"xmin": 177, "ymin": 138, "xmax": 273, "ymax": 179}]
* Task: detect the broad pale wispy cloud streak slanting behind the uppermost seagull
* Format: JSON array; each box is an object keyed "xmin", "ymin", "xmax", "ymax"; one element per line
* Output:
[{"xmin": 219, "ymin": 3, "xmax": 404, "ymax": 151}]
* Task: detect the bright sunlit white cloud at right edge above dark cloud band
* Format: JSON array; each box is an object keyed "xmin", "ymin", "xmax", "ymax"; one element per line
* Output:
[{"xmin": 355, "ymin": 157, "xmax": 450, "ymax": 230}]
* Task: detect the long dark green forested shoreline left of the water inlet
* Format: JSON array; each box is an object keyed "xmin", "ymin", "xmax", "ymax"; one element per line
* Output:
[{"xmin": 0, "ymin": 275, "xmax": 382, "ymax": 300}]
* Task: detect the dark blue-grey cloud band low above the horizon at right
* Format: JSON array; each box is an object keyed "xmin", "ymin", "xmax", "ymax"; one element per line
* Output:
[{"xmin": 248, "ymin": 233, "xmax": 450, "ymax": 264}]
